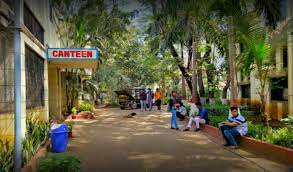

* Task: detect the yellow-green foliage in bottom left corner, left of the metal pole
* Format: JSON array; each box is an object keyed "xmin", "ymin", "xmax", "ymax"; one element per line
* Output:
[{"xmin": 0, "ymin": 139, "xmax": 14, "ymax": 172}]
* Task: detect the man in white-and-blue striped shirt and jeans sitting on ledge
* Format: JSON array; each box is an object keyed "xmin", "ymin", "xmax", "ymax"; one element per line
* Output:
[{"xmin": 219, "ymin": 107, "xmax": 248, "ymax": 149}]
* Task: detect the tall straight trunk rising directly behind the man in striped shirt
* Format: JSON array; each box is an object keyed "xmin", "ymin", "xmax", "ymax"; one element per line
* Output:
[{"xmin": 228, "ymin": 16, "xmax": 238, "ymax": 106}]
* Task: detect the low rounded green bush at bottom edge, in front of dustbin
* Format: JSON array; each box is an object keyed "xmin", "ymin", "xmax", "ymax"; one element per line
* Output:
[{"xmin": 37, "ymin": 153, "xmax": 81, "ymax": 172}]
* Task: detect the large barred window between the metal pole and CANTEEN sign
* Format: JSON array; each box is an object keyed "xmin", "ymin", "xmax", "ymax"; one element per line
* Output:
[{"xmin": 25, "ymin": 45, "xmax": 44, "ymax": 109}]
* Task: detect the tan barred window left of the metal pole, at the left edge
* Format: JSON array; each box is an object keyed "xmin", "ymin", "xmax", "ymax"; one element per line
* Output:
[{"xmin": 0, "ymin": 34, "xmax": 14, "ymax": 114}]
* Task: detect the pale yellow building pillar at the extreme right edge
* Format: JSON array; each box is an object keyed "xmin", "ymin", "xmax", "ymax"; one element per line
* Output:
[{"xmin": 287, "ymin": 30, "xmax": 293, "ymax": 115}]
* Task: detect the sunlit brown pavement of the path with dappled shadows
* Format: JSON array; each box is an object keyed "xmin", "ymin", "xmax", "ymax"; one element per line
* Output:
[{"xmin": 69, "ymin": 108, "xmax": 288, "ymax": 172}]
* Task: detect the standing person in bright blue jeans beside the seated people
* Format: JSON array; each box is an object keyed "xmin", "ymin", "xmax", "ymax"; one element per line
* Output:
[{"xmin": 169, "ymin": 91, "xmax": 181, "ymax": 130}]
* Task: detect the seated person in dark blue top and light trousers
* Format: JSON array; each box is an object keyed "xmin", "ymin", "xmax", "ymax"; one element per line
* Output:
[{"xmin": 184, "ymin": 102, "xmax": 208, "ymax": 131}]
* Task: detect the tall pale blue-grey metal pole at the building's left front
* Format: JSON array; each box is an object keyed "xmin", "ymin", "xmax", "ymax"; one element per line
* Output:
[{"xmin": 14, "ymin": 0, "xmax": 21, "ymax": 172}]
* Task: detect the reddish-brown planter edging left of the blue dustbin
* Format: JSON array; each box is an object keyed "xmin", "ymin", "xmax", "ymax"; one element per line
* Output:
[{"xmin": 21, "ymin": 141, "xmax": 50, "ymax": 172}]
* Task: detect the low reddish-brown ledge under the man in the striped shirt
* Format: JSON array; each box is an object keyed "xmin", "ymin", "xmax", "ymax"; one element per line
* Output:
[{"xmin": 201, "ymin": 125, "xmax": 293, "ymax": 165}]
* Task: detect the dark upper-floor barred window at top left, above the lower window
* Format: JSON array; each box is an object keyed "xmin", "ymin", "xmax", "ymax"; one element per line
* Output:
[{"xmin": 23, "ymin": 3, "xmax": 44, "ymax": 44}]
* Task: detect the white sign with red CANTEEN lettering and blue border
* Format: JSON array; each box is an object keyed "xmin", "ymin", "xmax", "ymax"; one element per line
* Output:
[{"xmin": 46, "ymin": 48, "xmax": 99, "ymax": 60}]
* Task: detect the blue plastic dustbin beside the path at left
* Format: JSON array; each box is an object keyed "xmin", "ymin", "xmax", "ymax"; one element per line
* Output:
[{"xmin": 50, "ymin": 124, "xmax": 68, "ymax": 153}]
